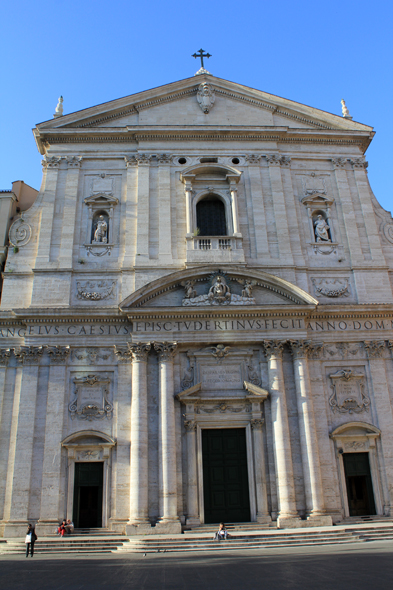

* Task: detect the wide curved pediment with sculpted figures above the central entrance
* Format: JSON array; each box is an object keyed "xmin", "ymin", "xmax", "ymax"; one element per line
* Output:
[{"xmin": 119, "ymin": 267, "xmax": 318, "ymax": 312}]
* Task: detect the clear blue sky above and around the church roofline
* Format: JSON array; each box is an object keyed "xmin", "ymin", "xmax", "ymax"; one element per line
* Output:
[{"xmin": 0, "ymin": 0, "xmax": 393, "ymax": 211}]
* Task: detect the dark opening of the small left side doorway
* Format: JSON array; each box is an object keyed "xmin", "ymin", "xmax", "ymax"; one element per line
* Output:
[{"xmin": 74, "ymin": 463, "xmax": 104, "ymax": 529}]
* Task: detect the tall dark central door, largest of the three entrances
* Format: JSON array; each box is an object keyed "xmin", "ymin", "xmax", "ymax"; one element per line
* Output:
[{"xmin": 202, "ymin": 428, "xmax": 250, "ymax": 523}]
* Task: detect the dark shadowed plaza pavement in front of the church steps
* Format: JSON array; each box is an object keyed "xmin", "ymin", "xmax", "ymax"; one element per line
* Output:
[{"xmin": 0, "ymin": 541, "xmax": 393, "ymax": 590}]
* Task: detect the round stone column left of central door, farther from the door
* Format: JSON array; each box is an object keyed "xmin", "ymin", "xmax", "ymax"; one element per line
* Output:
[{"xmin": 126, "ymin": 343, "xmax": 151, "ymax": 534}]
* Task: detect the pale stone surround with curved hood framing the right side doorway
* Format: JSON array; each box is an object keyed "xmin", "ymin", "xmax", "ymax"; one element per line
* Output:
[{"xmin": 330, "ymin": 422, "xmax": 382, "ymax": 517}]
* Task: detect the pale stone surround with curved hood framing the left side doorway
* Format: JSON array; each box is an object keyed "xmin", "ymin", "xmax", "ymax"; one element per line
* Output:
[{"xmin": 61, "ymin": 430, "xmax": 116, "ymax": 527}]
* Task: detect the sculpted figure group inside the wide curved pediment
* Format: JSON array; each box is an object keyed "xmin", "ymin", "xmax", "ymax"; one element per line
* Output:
[{"xmin": 182, "ymin": 274, "xmax": 255, "ymax": 307}]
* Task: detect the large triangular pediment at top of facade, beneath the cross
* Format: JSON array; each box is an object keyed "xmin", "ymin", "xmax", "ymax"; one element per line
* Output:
[{"xmin": 35, "ymin": 75, "xmax": 372, "ymax": 148}]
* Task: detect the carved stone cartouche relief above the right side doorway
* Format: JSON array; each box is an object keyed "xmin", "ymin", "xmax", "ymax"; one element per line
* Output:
[{"xmin": 329, "ymin": 369, "xmax": 370, "ymax": 414}]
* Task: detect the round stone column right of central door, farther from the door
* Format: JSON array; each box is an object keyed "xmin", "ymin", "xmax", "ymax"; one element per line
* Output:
[{"xmin": 289, "ymin": 340, "xmax": 332, "ymax": 526}]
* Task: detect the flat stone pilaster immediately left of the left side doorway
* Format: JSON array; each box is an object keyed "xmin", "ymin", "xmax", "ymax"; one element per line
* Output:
[{"xmin": 37, "ymin": 346, "xmax": 70, "ymax": 535}]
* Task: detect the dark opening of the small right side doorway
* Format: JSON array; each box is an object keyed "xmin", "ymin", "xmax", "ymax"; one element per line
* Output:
[{"xmin": 343, "ymin": 453, "xmax": 375, "ymax": 516}]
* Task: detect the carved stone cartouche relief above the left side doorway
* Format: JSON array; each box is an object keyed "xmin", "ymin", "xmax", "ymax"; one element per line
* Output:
[{"xmin": 68, "ymin": 375, "xmax": 113, "ymax": 422}]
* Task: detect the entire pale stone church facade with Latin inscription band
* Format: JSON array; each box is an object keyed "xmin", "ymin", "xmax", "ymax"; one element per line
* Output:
[{"xmin": 0, "ymin": 70, "xmax": 393, "ymax": 537}]
